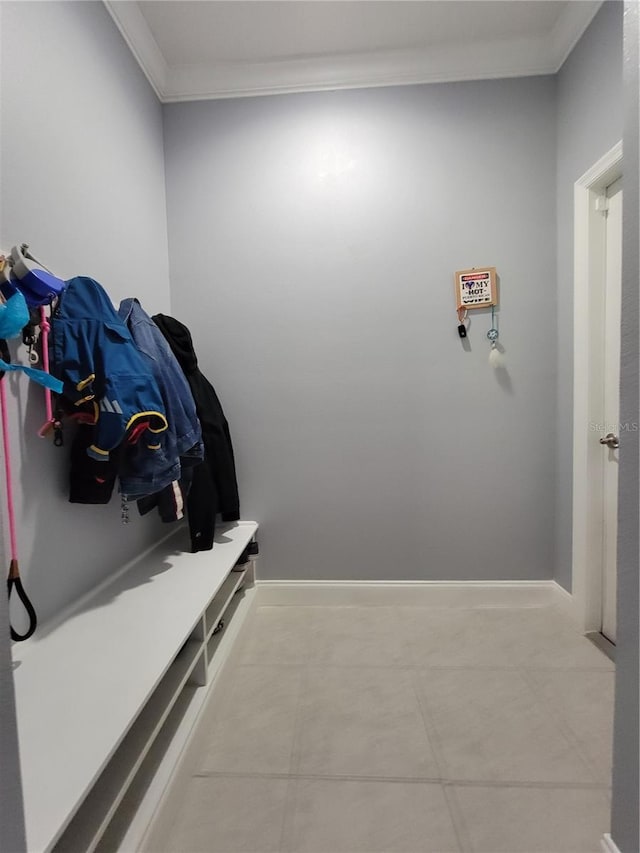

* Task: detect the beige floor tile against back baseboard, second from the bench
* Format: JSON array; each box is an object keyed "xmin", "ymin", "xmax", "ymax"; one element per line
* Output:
[{"xmin": 309, "ymin": 607, "xmax": 407, "ymax": 666}]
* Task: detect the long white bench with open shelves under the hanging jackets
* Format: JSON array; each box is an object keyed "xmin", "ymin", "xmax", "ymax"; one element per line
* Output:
[{"xmin": 14, "ymin": 521, "xmax": 258, "ymax": 853}]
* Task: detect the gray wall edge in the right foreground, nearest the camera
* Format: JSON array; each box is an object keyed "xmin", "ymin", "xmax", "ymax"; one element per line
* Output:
[{"xmin": 611, "ymin": 2, "xmax": 640, "ymax": 853}]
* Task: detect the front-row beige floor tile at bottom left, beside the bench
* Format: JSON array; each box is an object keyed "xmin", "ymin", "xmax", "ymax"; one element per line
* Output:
[{"xmin": 145, "ymin": 776, "xmax": 288, "ymax": 853}]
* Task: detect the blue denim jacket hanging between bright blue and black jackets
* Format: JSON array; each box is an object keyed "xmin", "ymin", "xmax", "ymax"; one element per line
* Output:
[{"xmin": 118, "ymin": 298, "xmax": 204, "ymax": 500}]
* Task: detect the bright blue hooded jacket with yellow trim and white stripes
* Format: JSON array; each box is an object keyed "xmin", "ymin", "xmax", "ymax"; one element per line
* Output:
[{"xmin": 51, "ymin": 276, "xmax": 167, "ymax": 461}]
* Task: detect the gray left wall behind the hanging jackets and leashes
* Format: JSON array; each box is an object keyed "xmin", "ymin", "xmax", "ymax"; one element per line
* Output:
[{"xmin": 0, "ymin": 2, "xmax": 170, "ymax": 620}]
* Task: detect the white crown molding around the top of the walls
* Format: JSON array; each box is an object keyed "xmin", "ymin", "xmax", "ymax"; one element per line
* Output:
[{"xmin": 103, "ymin": 0, "xmax": 603, "ymax": 103}]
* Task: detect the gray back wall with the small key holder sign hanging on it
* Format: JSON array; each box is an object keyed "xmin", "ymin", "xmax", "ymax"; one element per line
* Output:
[{"xmin": 165, "ymin": 78, "xmax": 556, "ymax": 579}]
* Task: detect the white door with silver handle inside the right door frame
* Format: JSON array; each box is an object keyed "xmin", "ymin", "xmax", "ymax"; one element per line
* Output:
[{"xmin": 600, "ymin": 178, "xmax": 622, "ymax": 643}]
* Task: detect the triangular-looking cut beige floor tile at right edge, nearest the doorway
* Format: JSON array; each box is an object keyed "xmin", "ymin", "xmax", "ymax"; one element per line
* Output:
[{"xmin": 527, "ymin": 670, "xmax": 615, "ymax": 785}]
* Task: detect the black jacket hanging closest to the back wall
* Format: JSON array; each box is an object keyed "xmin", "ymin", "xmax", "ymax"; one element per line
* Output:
[{"xmin": 152, "ymin": 314, "xmax": 240, "ymax": 551}]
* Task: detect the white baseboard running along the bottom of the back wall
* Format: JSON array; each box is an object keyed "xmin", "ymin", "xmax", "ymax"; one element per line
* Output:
[{"xmin": 256, "ymin": 580, "xmax": 572, "ymax": 613}]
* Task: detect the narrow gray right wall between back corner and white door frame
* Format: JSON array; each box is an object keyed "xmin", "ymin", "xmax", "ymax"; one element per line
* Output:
[{"xmin": 555, "ymin": 0, "xmax": 623, "ymax": 590}]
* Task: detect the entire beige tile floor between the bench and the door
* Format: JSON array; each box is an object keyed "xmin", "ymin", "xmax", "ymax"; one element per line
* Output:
[{"xmin": 145, "ymin": 607, "xmax": 614, "ymax": 853}]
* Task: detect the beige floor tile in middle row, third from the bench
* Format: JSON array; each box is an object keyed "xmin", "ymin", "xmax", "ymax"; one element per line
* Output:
[{"xmin": 417, "ymin": 669, "xmax": 594, "ymax": 783}]
